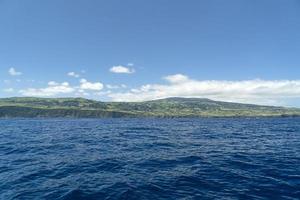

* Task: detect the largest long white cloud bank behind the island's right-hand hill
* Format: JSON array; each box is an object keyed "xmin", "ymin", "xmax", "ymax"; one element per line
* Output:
[{"xmin": 109, "ymin": 74, "xmax": 300, "ymax": 104}]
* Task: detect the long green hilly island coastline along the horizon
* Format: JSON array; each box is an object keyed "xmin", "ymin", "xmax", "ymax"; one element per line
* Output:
[{"xmin": 0, "ymin": 97, "xmax": 300, "ymax": 118}]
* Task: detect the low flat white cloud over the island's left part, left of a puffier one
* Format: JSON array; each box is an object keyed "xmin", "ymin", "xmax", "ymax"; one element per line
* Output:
[{"xmin": 19, "ymin": 81, "xmax": 75, "ymax": 97}]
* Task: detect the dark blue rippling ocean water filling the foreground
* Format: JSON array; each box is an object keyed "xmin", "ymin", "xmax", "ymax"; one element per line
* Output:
[{"xmin": 0, "ymin": 118, "xmax": 300, "ymax": 200}]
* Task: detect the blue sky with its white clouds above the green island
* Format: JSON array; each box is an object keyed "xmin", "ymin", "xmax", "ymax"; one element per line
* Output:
[{"xmin": 0, "ymin": 0, "xmax": 300, "ymax": 107}]
